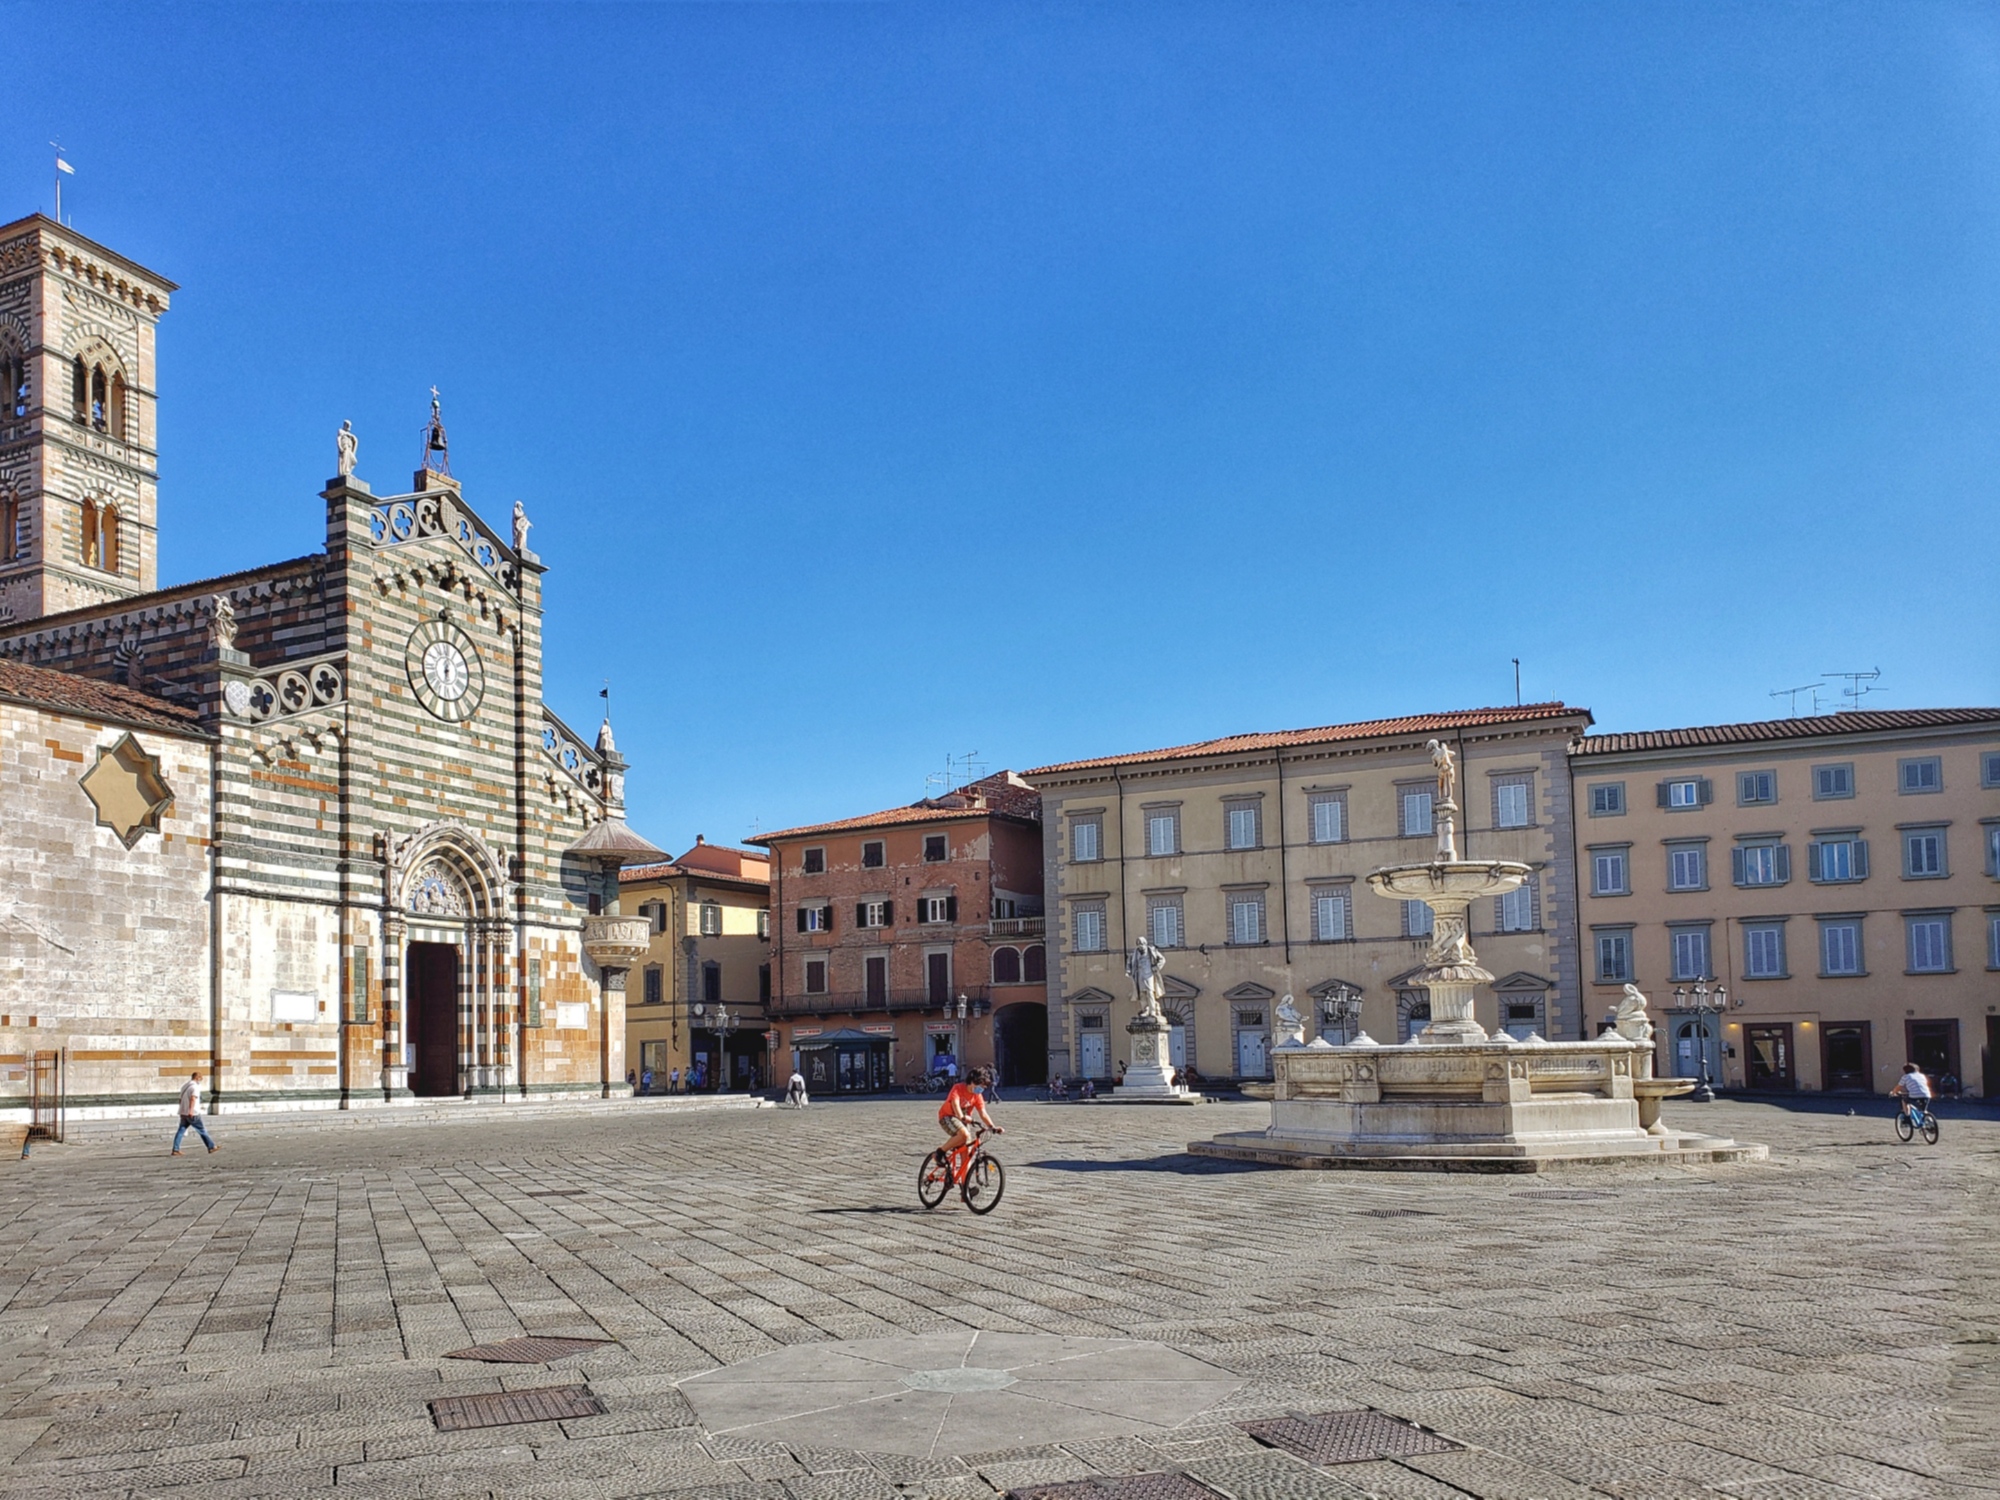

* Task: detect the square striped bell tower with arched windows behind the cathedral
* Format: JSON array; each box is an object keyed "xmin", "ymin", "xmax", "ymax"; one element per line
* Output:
[{"xmin": 0, "ymin": 214, "xmax": 180, "ymax": 624}]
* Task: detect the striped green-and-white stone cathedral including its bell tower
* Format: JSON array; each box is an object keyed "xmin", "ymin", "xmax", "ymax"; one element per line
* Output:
[{"xmin": 0, "ymin": 216, "xmax": 660, "ymax": 1112}]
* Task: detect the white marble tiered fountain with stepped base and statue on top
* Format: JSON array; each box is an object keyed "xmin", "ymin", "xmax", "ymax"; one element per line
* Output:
[{"xmin": 1184, "ymin": 740, "xmax": 1768, "ymax": 1172}]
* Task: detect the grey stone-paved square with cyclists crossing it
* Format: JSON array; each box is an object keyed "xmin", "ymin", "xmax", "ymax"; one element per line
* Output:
[{"xmin": 0, "ymin": 1100, "xmax": 2000, "ymax": 1500}]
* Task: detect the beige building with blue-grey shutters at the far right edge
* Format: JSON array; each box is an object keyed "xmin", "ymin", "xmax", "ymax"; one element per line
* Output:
[{"xmin": 1572, "ymin": 708, "xmax": 2000, "ymax": 1094}]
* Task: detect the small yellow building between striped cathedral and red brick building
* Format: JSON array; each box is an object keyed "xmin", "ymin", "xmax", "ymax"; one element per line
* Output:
[{"xmin": 618, "ymin": 838, "xmax": 784, "ymax": 1094}]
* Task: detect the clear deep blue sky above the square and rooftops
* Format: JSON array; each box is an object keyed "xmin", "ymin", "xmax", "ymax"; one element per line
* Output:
[{"xmin": 0, "ymin": 4, "xmax": 2000, "ymax": 848}]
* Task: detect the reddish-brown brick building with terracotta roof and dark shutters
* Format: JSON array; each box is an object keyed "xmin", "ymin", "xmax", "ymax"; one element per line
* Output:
[{"xmin": 750, "ymin": 772, "xmax": 1048, "ymax": 1092}]
